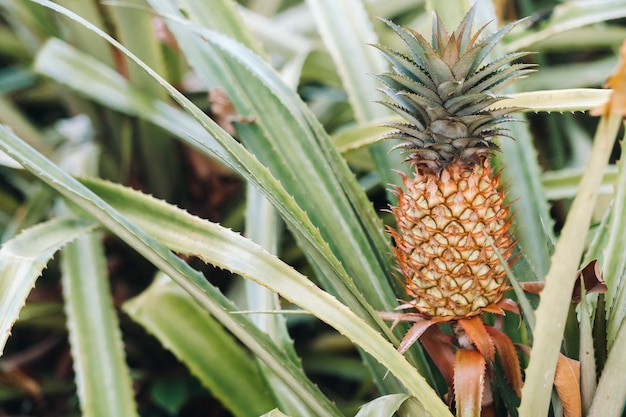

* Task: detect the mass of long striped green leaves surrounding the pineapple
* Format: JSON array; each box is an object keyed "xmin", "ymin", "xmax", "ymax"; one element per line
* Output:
[{"xmin": 0, "ymin": 0, "xmax": 626, "ymax": 417}]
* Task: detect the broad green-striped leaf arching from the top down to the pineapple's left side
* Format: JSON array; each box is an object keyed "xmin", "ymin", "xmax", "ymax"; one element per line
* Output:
[{"xmin": 150, "ymin": 0, "xmax": 396, "ymax": 321}]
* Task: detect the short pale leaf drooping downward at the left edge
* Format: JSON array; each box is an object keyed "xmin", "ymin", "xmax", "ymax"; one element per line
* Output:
[{"xmin": 0, "ymin": 218, "xmax": 97, "ymax": 352}]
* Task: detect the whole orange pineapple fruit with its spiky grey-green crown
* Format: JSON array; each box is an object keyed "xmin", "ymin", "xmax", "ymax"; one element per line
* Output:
[{"xmin": 376, "ymin": 7, "xmax": 532, "ymax": 320}]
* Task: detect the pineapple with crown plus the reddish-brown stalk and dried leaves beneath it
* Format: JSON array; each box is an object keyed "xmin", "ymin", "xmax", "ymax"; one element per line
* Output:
[{"xmin": 377, "ymin": 6, "xmax": 533, "ymax": 416}]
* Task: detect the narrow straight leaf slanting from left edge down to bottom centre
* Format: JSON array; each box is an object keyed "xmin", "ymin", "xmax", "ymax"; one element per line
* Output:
[{"xmin": 0, "ymin": 126, "xmax": 339, "ymax": 416}]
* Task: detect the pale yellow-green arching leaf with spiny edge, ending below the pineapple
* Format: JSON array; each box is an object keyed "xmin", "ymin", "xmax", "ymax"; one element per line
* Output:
[{"xmin": 75, "ymin": 179, "xmax": 447, "ymax": 412}]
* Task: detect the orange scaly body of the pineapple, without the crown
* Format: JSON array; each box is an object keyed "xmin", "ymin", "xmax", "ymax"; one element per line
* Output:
[{"xmin": 388, "ymin": 158, "xmax": 515, "ymax": 318}]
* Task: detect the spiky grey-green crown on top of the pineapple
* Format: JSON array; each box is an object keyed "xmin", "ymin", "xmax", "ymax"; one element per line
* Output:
[{"xmin": 373, "ymin": 6, "xmax": 534, "ymax": 171}]
